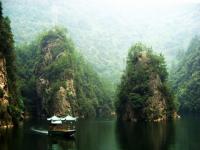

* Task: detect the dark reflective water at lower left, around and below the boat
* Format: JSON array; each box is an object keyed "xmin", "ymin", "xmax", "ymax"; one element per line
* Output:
[{"xmin": 0, "ymin": 121, "xmax": 76, "ymax": 150}]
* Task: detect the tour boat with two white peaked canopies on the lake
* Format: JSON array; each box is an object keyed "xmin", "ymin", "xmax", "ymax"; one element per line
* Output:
[{"xmin": 47, "ymin": 115, "xmax": 77, "ymax": 138}]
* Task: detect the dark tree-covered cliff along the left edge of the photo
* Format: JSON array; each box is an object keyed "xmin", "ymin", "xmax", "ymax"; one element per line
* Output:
[{"xmin": 0, "ymin": 2, "xmax": 23, "ymax": 127}]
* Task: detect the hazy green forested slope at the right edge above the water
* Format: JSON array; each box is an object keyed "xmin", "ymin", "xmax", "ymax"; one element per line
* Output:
[{"xmin": 171, "ymin": 36, "xmax": 200, "ymax": 112}]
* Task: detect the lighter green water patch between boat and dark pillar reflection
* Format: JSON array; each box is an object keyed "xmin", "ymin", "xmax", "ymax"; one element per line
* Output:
[{"xmin": 76, "ymin": 120, "xmax": 118, "ymax": 150}]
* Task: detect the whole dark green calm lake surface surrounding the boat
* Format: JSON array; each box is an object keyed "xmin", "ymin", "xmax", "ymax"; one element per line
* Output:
[{"xmin": 0, "ymin": 115, "xmax": 200, "ymax": 150}]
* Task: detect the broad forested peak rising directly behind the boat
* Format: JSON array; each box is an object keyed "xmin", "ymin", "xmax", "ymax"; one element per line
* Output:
[{"xmin": 16, "ymin": 27, "xmax": 113, "ymax": 117}]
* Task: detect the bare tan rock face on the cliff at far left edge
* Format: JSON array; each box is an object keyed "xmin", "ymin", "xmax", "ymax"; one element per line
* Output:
[{"xmin": 0, "ymin": 57, "xmax": 12, "ymax": 126}]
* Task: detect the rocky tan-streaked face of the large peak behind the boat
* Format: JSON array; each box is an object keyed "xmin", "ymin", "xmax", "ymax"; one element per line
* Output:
[{"xmin": 35, "ymin": 34, "xmax": 76, "ymax": 116}]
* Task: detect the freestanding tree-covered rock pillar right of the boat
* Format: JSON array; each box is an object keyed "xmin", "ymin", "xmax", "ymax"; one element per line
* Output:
[{"xmin": 116, "ymin": 43, "xmax": 176, "ymax": 121}]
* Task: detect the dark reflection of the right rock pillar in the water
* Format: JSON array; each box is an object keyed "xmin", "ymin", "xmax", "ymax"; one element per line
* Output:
[{"xmin": 116, "ymin": 122, "xmax": 175, "ymax": 150}]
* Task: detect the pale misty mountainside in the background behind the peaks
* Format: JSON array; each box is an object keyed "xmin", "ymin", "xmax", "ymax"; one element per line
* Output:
[{"xmin": 2, "ymin": 0, "xmax": 200, "ymax": 83}]
